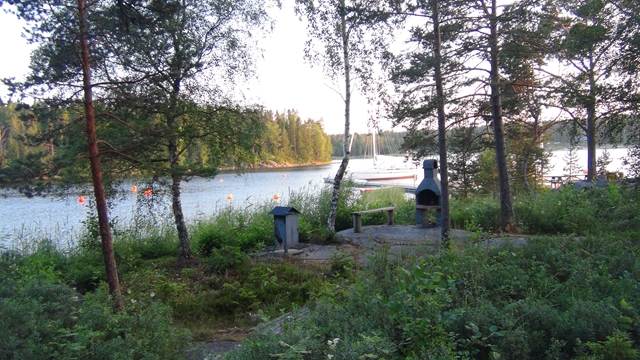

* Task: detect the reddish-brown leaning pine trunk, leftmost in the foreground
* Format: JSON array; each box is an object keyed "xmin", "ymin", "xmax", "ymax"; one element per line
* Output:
[{"xmin": 78, "ymin": 0, "xmax": 124, "ymax": 309}]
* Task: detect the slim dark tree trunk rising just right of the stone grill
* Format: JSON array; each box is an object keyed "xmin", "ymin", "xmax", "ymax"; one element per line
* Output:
[{"xmin": 432, "ymin": 0, "xmax": 451, "ymax": 248}]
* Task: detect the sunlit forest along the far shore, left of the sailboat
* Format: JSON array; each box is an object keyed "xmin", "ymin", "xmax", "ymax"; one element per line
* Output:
[{"xmin": 0, "ymin": 104, "xmax": 332, "ymax": 195}]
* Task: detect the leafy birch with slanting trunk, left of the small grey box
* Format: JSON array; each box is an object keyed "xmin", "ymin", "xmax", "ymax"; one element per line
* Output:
[{"xmin": 99, "ymin": 0, "xmax": 270, "ymax": 258}]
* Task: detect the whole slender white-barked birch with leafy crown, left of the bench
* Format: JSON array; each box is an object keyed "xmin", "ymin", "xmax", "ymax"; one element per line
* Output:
[{"xmin": 296, "ymin": 0, "xmax": 396, "ymax": 232}]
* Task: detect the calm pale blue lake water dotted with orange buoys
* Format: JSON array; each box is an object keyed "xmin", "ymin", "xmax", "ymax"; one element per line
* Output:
[{"xmin": 0, "ymin": 149, "xmax": 626, "ymax": 248}]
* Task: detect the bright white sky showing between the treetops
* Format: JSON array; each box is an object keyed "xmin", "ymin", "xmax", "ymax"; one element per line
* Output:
[{"xmin": 0, "ymin": 2, "xmax": 380, "ymax": 134}]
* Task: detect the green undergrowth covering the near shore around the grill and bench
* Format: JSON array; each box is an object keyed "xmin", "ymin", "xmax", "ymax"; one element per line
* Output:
[{"xmin": 0, "ymin": 180, "xmax": 640, "ymax": 359}]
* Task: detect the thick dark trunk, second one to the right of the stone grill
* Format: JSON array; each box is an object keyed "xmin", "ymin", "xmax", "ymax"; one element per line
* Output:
[{"xmin": 489, "ymin": 0, "xmax": 516, "ymax": 232}]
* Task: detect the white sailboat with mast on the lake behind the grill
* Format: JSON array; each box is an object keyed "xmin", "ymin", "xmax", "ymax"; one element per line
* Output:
[{"xmin": 349, "ymin": 132, "xmax": 419, "ymax": 182}]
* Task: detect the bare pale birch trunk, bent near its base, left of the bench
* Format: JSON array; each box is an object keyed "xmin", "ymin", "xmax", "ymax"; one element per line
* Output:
[{"xmin": 327, "ymin": 1, "xmax": 351, "ymax": 232}]
